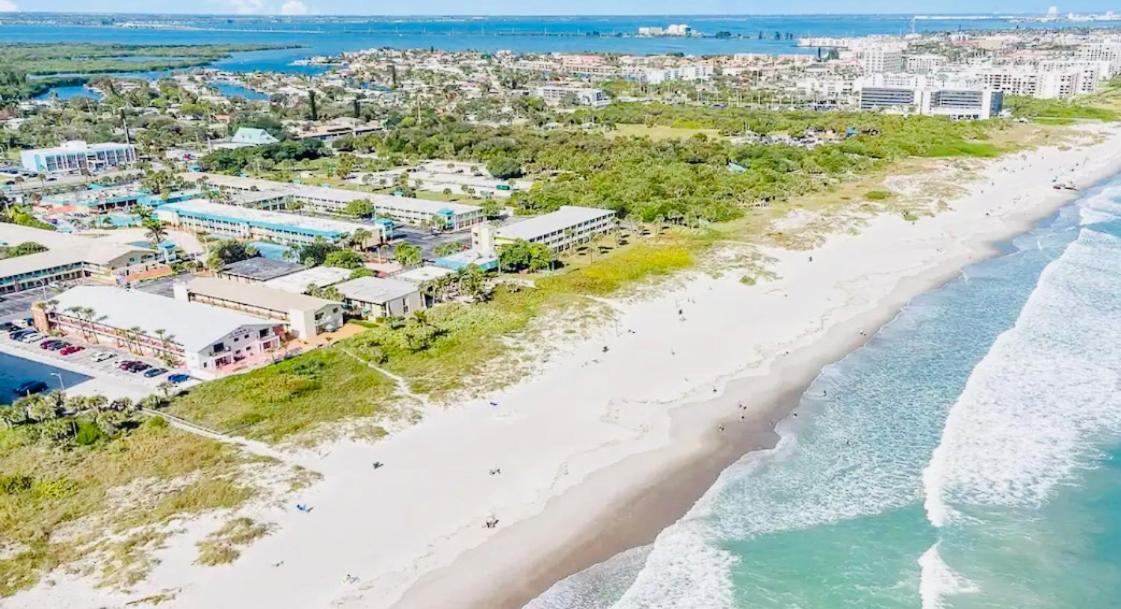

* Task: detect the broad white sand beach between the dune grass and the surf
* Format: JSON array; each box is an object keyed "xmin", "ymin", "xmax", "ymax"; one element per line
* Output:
[{"xmin": 13, "ymin": 122, "xmax": 1121, "ymax": 609}]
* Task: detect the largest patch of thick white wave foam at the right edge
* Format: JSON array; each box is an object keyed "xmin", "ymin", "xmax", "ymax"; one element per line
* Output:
[{"xmin": 923, "ymin": 228, "xmax": 1121, "ymax": 527}]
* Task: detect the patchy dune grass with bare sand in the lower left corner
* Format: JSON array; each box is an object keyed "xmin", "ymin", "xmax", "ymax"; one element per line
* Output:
[{"xmin": 0, "ymin": 418, "xmax": 253, "ymax": 597}]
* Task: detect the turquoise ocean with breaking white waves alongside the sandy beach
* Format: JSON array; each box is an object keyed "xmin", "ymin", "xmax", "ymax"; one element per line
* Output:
[{"xmin": 527, "ymin": 177, "xmax": 1121, "ymax": 609}]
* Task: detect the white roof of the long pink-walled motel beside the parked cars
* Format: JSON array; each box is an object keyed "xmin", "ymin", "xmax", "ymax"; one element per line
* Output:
[{"xmin": 54, "ymin": 286, "xmax": 277, "ymax": 351}]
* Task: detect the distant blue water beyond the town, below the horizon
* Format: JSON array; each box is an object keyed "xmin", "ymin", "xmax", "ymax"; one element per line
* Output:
[{"xmin": 0, "ymin": 15, "xmax": 1121, "ymax": 77}]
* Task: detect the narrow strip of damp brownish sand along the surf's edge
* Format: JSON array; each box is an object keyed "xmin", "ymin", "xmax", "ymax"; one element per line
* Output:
[{"xmin": 391, "ymin": 122, "xmax": 1121, "ymax": 609}]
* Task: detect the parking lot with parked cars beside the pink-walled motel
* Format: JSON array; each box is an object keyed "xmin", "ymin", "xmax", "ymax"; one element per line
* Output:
[{"xmin": 0, "ymin": 332, "xmax": 197, "ymax": 399}]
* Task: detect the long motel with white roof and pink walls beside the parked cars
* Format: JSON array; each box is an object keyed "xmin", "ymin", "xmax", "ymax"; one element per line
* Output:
[{"xmin": 40, "ymin": 286, "xmax": 282, "ymax": 378}]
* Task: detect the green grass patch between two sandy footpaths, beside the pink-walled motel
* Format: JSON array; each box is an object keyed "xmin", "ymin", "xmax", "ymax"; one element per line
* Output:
[{"xmin": 168, "ymin": 348, "xmax": 393, "ymax": 442}]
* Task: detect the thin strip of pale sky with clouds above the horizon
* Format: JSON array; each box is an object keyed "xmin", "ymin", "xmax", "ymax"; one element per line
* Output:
[{"xmin": 0, "ymin": 0, "xmax": 1121, "ymax": 15}]
